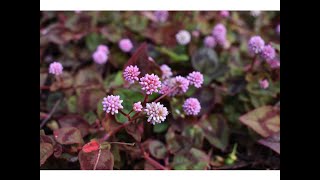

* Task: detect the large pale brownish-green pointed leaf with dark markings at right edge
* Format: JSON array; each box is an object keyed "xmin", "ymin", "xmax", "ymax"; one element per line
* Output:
[{"xmin": 240, "ymin": 106, "xmax": 280, "ymax": 137}]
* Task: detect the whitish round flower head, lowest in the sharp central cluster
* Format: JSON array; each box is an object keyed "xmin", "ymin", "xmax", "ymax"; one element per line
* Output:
[{"xmin": 144, "ymin": 102, "xmax": 169, "ymax": 125}]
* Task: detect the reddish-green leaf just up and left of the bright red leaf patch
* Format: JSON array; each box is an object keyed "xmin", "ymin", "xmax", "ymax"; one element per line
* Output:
[{"xmin": 53, "ymin": 127, "xmax": 83, "ymax": 144}]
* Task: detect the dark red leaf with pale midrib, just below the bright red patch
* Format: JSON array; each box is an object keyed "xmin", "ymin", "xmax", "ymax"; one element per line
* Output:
[{"xmin": 79, "ymin": 149, "xmax": 114, "ymax": 170}]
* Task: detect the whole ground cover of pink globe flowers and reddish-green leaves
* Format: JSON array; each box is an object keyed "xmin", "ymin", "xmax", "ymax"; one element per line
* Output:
[{"xmin": 40, "ymin": 11, "xmax": 280, "ymax": 170}]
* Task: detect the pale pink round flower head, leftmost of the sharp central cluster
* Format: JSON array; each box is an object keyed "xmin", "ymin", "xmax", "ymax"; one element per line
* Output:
[{"xmin": 102, "ymin": 95, "xmax": 123, "ymax": 115}]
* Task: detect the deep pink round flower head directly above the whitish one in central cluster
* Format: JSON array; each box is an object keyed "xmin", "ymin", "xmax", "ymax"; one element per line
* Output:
[{"xmin": 140, "ymin": 74, "xmax": 161, "ymax": 95}]
